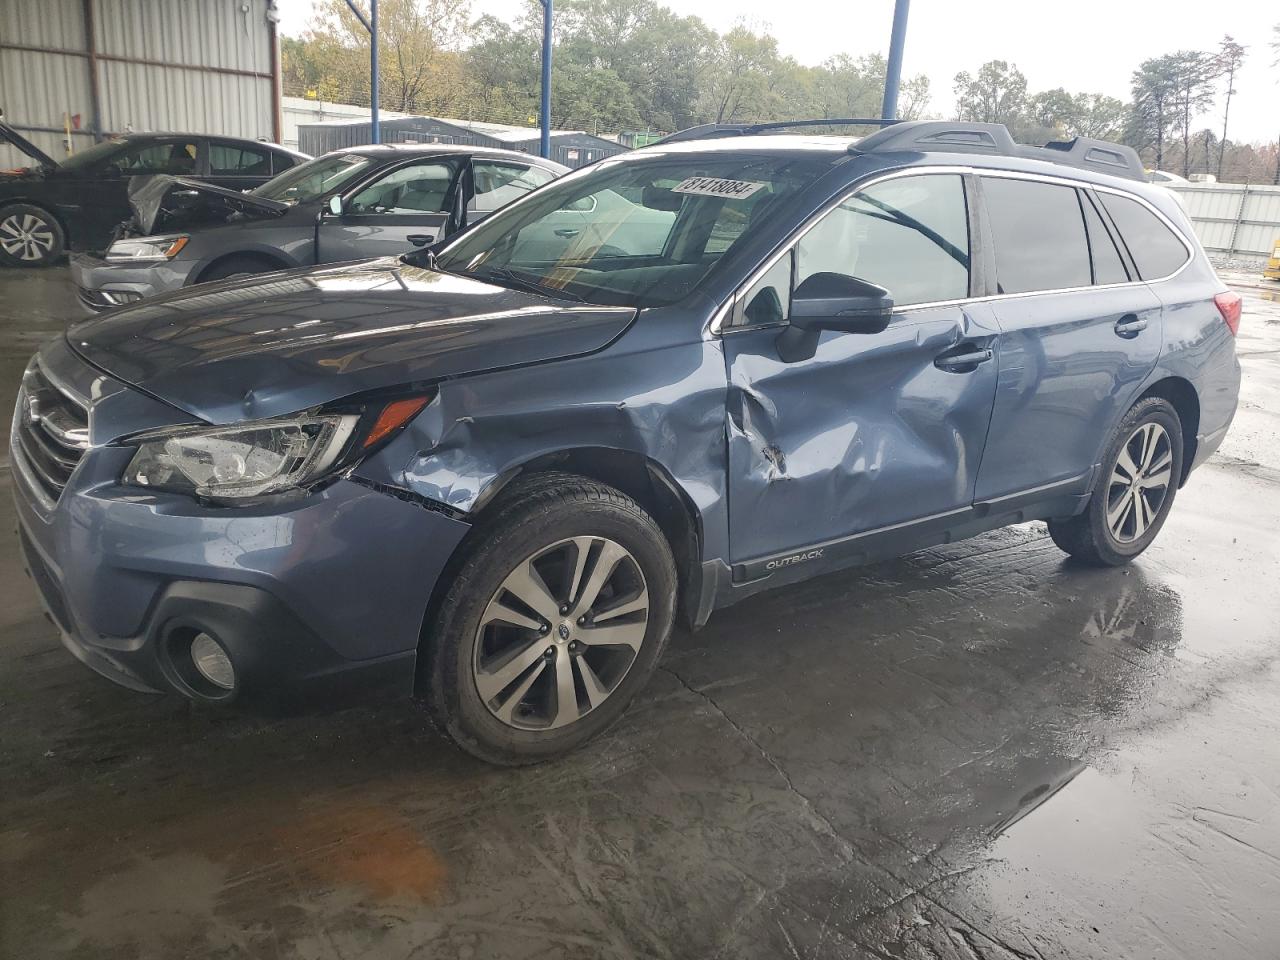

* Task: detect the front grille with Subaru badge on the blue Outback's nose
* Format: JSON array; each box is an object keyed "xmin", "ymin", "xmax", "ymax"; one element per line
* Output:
[{"xmin": 14, "ymin": 364, "xmax": 88, "ymax": 502}]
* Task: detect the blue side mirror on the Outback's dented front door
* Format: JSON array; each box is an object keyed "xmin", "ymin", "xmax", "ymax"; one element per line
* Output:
[{"xmin": 778, "ymin": 273, "xmax": 893, "ymax": 364}]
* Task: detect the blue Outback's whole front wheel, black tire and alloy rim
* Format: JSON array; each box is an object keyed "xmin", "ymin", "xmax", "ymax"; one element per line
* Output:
[{"xmin": 422, "ymin": 472, "xmax": 677, "ymax": 765}]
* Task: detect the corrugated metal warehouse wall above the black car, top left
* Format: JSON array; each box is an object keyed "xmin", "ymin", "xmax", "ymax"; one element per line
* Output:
[{"xmin": 0, "ymin": 0, "xmax": 280, "ymax": 168}]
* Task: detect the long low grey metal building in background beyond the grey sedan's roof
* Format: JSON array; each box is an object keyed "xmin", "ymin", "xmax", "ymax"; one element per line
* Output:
[{"xmin": 298, "ymin": 116, "xmax": 626, "ymax": 168}]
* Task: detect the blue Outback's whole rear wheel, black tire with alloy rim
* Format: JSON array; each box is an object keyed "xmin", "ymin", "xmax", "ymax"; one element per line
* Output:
[{"xmin": 1048, "ymin": 397, "xmax": 1183, "ymax": 567}]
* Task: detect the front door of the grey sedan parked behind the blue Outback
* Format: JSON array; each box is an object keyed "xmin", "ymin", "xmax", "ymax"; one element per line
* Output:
[{"xmin": 316, "ymin": 157, "xmax": 462, "ymax": 264}]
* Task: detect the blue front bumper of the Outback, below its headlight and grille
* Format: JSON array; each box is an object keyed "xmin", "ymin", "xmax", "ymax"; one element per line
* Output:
[{"xmin": 10, "ymin": 351, "xmax": 467, "ymax": 713}]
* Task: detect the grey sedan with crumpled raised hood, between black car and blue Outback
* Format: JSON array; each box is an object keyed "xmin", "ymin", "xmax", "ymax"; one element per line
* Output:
[{"xmin": 72, "ymin": 145, "xmax": 568, "ymax": 311}]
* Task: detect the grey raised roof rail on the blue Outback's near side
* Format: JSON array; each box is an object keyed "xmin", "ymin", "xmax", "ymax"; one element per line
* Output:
[{"xmin": 850, "ymin": 120, "xmax": 1147, "ymax": 182}]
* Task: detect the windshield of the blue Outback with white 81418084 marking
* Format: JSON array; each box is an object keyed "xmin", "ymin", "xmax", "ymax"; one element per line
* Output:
[{"xmin": 436, "ymin": 152, "xmax": 831, "ymax": 307}]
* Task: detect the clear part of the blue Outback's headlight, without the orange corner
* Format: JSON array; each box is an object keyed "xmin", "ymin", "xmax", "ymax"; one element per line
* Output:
[{"xmin": 123, "ymin": 415, "xmax": 360, "ymax": 499}]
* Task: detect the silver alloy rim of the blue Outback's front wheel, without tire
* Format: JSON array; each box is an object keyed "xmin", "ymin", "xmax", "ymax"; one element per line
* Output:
[{"xmin": 472, "ymin": 536, "xmax": 649, "ymax": 730}]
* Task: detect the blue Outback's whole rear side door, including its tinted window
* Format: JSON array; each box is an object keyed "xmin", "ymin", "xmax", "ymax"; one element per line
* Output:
[{"xmin": 975, "ymin": 174, "xmax": 1161, "ymax": 500}]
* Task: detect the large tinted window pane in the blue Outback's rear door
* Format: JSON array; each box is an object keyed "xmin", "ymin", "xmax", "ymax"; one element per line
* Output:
[{"xmin": 983, "ymin": 177, "xmax": 1092, "ymax": 293}]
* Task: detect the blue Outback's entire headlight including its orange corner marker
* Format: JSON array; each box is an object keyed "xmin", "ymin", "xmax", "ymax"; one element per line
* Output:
[{"xmin": 120, "ymin": 393, "xmax": 434, "ymax": 500}]
